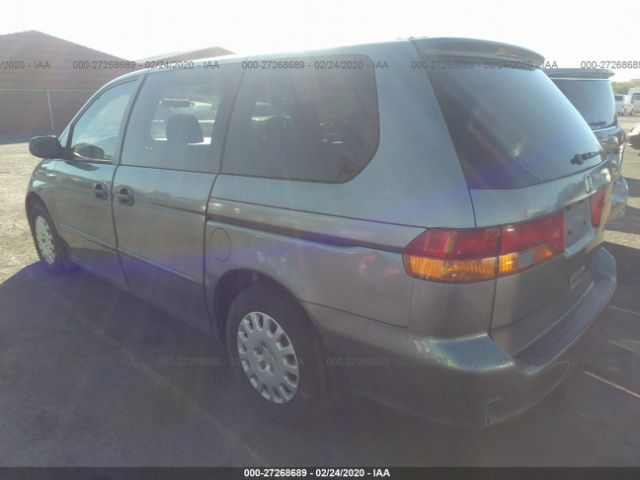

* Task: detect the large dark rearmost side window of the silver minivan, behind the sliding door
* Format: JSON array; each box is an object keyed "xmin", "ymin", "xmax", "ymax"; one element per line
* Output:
[{"xmin": 222, "ymin": 56, "xmax": 379, "ymax": 183}]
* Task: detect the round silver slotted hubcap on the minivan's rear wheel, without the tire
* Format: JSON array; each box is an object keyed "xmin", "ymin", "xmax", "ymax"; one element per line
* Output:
[{"xmin": 238, "ymin": 312, "xmax": 300, "ymax": 403}]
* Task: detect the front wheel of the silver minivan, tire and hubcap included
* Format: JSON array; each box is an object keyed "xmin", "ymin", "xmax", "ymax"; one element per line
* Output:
[{"xmin": 29, "ymin": 202, "xmax": 71, "ymax": 274}]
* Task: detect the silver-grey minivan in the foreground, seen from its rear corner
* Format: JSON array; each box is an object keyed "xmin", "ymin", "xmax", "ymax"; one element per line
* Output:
[{"xmin": 26, "ymin": 38, "xmax": 616, "ymax": 426}]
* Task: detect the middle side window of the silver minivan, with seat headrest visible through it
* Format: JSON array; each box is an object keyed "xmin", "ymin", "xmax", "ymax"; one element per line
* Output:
[{"xmin": 122, "ymin": 70, "xmax": 223, "ymax": 172}]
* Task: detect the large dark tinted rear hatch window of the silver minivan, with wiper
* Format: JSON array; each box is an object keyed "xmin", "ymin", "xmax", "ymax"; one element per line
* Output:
[{"xmin": 427, "ymin": 62, "xmax": 602, "ymax": 189}]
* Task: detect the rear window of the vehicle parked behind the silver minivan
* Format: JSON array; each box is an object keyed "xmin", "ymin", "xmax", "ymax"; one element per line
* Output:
[{"xmin": 553, "ymin": 78, "xmax": 616, "ymax": 128}]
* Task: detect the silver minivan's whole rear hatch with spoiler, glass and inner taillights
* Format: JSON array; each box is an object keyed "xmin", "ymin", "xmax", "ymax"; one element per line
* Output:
[{"xmin": 415, "ymin": 39, "xmax": 611, "ymax": 353}]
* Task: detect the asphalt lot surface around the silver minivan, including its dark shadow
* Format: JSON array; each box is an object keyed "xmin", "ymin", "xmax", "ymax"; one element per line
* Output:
[{"xmin": 0, "ymin": 119, "xmax": 640, "ymax": 466}]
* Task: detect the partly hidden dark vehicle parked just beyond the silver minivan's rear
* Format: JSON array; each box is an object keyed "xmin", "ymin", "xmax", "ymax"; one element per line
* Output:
[{"xmin": 545, "ymin": 68, "xmax": 629, "ymax": 220}]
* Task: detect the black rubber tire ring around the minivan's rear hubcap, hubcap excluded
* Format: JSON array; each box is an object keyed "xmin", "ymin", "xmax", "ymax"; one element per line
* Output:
[{"xmin": 226, "ymin": 283, "xmax": 326, "ymax": 424}]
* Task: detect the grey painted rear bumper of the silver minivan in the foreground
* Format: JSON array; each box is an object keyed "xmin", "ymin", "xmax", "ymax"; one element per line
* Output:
[{"xmin": 305, "ymin": 248, "xmax": 616, "ymax": 427}]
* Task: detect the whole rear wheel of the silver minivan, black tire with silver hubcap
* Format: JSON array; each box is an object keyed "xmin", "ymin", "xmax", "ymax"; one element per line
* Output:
[{"xmin": 226, "ymin": 283, "xmax": 328, "ymax": 425}]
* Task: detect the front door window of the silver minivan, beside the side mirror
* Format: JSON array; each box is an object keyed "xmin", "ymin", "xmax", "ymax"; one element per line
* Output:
[{"xmin": 71, "ymin": 81, "xmax": 138, "ymax": 160}]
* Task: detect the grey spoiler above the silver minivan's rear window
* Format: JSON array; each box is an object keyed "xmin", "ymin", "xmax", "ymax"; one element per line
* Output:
[{"xmin": 411, "ymin": 38, "xmax": 544, "ymax": 67}]
